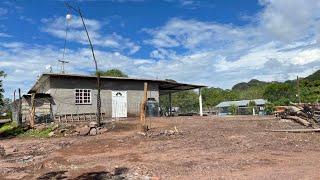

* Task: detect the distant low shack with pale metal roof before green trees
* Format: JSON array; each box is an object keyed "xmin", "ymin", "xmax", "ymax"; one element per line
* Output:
[{"xmin": 216, "ymin": 99, "xmax": 267, "ymax": 115}]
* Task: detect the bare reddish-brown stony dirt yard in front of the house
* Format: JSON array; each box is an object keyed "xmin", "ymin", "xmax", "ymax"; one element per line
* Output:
[{"xmin": 0, "ymin": 116, "xmax": 320, "ymax": 179}]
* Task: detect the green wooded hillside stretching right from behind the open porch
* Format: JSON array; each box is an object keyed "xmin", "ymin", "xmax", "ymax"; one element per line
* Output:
[{"xmin": 160, "ymin": 70, "xmax": 320, "ymax": 111}]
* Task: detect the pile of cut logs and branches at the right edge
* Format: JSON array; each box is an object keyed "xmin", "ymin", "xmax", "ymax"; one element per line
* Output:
[{"xmin": 274, "ymin": 103, "xmax": 320, "ymax": 128}]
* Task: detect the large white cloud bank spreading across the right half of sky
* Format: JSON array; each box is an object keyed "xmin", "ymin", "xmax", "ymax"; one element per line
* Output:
[{"xmin": 144, "ymin": 0, "xmax": 320, "ymax": 87}]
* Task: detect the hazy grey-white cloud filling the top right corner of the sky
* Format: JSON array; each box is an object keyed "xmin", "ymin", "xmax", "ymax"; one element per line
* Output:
[{"xmin": 258, "ymin": 0, "xmax": 320, "ymax": 41}]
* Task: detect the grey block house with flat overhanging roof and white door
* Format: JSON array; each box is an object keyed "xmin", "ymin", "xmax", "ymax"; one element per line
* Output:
[{"xmin": 18, "ymin": 73, "xmax": 205, "ymax": 122}]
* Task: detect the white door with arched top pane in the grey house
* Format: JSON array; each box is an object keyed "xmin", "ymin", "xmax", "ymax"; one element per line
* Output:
[{"xmin": 112, "ymin": 91, "xmax": 127, "ymax": 118}]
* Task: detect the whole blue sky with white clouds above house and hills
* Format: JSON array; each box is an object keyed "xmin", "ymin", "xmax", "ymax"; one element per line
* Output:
[{"xmin": 0, "ymin": 0, "xmax": 320, "ymax": 97}]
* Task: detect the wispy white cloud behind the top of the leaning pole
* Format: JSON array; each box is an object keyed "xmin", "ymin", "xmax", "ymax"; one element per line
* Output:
[{"xmin": 42, "ymin": 16, "xmax": 140, "ymax": 54}]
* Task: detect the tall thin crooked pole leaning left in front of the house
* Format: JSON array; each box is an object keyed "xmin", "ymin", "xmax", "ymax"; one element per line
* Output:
[{"xmin": 65, "ymin": 3, "xmax": 101, "ymax": 126}]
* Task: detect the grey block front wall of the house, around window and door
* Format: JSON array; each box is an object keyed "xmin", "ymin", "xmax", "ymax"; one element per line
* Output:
[{"xmin": 47, "ymin": 77, "xmax": 159, "ymax": 117}]
